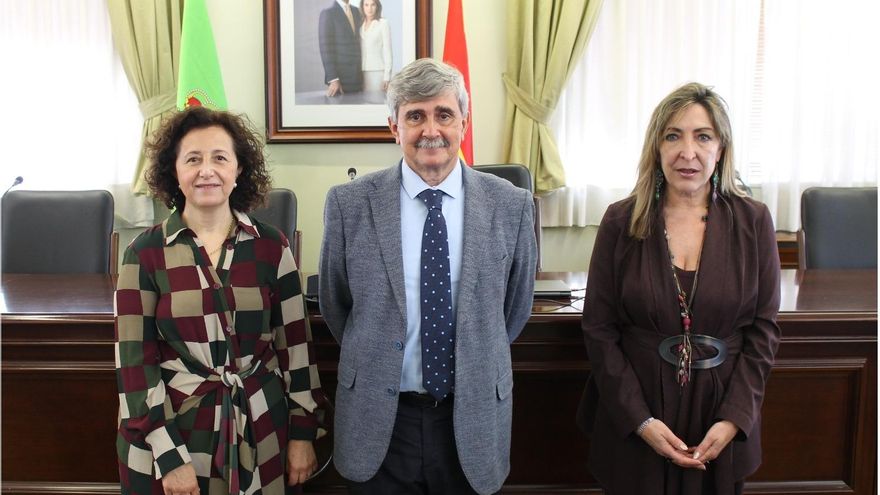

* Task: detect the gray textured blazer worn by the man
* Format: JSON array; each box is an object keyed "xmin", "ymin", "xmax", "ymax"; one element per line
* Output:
[{"xmin": 320, "ymin": 162, "xmax": 536, "ymax": 493}]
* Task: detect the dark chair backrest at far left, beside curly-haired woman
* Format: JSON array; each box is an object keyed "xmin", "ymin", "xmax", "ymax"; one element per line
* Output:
[{"xmin": 0, "ymin": 190, "xmax": 116, "ymax": 273}]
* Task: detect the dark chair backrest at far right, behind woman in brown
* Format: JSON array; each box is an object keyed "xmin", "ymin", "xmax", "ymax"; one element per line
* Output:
[{"xmin": 798, "ymin": 187, "xmax": 877, "ymax": 268}]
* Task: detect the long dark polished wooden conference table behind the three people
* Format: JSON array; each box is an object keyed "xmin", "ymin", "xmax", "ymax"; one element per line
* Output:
[{"xmin": 0, "ymin": 270, "xmax": 877, "ymax": 495}]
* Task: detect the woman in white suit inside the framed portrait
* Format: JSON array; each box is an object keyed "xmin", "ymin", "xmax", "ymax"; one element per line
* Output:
[{"xmin": 360, "ymin": 0, "xmax": 392, "ymax": 92}]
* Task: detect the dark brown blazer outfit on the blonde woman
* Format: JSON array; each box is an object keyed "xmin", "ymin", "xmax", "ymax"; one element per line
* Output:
[{"xmin": 578, "ymin": 196, "xmax": 780, "ymax": 495}]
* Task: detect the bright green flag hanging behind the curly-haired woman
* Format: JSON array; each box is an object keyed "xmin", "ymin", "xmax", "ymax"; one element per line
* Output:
[{"xmin": 177, "ymin": 0, "xmax": 228, "ymax": 110}]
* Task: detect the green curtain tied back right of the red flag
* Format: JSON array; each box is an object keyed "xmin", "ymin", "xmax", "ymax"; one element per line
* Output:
[{"xmin": 503, "ymin": 0, "xmax": 603, "ymax": 192}]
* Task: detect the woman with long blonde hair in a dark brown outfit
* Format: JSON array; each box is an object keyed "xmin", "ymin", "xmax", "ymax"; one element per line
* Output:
[{"xmin": 578, "ymin": 83, "xmax": 779, "ymax": 495}]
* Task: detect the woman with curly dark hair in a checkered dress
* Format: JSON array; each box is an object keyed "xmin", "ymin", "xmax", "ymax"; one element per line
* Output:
[{"xmin": 115, "ymin": 106, "xmax": 322, "ymax": 495}]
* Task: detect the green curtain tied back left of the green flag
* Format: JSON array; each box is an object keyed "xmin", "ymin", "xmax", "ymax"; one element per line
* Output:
[{"xmin": 107, "ymin": 0, "xmax": 184, "ymax": 194}]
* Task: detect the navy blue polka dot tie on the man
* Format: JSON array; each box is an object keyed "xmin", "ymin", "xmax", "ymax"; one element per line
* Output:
[{"xmin": 418, "ymin": 189, "xmax": 455, "ymax": 400}]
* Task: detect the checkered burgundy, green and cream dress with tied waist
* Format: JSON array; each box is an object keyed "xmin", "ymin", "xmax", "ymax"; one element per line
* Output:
[{"xmin": 115, "ymin": 212, "xmax": 320, "ymax": 495}]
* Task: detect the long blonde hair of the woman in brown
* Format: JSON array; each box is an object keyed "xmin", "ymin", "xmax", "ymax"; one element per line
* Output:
[{"xmin": 629, "ymin": 82, "xmax": 746, "ymax": 239}]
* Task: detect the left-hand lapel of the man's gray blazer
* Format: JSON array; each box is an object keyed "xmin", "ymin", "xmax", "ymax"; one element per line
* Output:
[{"xmin": 369, "ymin": 162, "xmax": 406, "ymax": 320}]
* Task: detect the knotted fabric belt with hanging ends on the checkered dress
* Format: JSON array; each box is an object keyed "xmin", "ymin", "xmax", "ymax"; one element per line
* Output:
[{"xmin": 214, "ymin": 361, "xmax": 266, "ymax": 495}]
